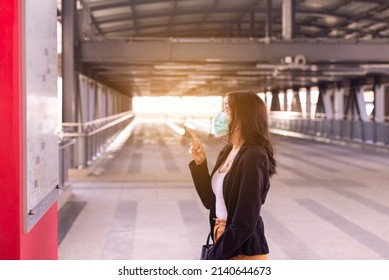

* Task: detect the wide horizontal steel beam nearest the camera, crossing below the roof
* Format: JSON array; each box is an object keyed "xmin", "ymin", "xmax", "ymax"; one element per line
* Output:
[{"xmin": 79, "ymin": 38, "xmax": 389, "ymax": 63}]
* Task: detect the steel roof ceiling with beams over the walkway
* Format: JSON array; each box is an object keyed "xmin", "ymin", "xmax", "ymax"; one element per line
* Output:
[{"xmin": 59, "ymin": 0, "xmax": 389, "ymax": 95}]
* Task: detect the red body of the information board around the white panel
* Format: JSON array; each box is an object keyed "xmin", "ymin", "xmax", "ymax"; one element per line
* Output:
[{"xmin": 0, "ymin": 0, "xmax": 58, "ymax": 259}]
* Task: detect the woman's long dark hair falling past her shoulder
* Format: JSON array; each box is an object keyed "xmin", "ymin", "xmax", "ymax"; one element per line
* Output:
[{"xmin": 226, "ymin": 91, "xmax": 277, "ymax": 176}]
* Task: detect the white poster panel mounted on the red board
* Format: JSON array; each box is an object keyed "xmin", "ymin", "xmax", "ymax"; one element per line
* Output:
[{"xmin": 23, "ymin": 0, "xmax": 59, "ymax": 232}]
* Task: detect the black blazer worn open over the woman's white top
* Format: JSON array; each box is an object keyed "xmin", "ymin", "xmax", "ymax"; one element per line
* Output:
[{"xmin": 189, "ymin": 144, "xmax": 270, "ymax": 260}]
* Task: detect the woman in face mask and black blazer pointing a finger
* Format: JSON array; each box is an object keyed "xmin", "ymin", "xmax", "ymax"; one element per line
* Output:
[{"xmin": 189, "ymin": 91, "xmax": 276, "ymax": 260}]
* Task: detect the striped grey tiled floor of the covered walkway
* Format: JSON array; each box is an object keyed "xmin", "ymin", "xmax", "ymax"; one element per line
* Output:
[{"xmin": 59, "ymin": 122, "xmax": 389, "ymax": 260}]
